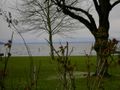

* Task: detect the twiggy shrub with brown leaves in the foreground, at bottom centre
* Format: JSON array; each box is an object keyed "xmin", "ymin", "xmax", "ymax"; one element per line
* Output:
[{"xmin": 55, "ymin": 42, "xmax": 76, "ymax": 90}]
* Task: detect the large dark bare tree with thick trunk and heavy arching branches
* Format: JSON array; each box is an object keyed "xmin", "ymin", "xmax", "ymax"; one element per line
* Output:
[{"xmin": 51, "ymin": 0, "xmax": 120, "ymax": 75}]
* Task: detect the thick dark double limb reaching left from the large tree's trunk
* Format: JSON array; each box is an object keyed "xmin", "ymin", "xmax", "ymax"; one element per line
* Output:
[{"xmin": 54, "ymin": 0, "xmax": 97, "ymax": 33}]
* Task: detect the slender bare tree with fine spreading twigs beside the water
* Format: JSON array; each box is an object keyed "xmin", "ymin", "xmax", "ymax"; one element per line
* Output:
[{"xmin": 18, "ymin": 0, "xmax": 74, "ymax": 59}]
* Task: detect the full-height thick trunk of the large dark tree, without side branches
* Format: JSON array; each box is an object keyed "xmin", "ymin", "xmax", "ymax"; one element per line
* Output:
[{"xmin": 93, "ymin": 0, "xmax": 110, "ymax": 76}]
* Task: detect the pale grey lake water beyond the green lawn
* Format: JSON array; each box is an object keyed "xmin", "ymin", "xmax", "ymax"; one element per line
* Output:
[{"xmin": 0, "ymin": 42, "xmax": 95, "ymax": 56}]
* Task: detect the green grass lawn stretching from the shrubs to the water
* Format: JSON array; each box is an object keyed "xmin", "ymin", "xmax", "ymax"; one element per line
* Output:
[{"xmin": 0, "ymin": 56, "xmax": 120, "ymax": 90}]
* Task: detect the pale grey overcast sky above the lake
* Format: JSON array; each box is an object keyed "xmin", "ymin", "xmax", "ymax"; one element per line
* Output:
[{"xmin": 0, "ymin": 0, "xmax": 120, "ymax": 43}]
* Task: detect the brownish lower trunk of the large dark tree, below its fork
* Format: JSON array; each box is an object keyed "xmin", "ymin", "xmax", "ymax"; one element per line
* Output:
[{"xmin": 94, "ymin": 27, "xmax": 109, "ymax": 76}]
